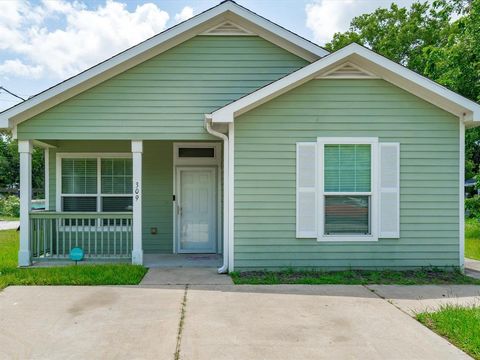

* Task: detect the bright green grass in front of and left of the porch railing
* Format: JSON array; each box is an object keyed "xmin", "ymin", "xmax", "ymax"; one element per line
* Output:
[{"xmin": 0, "ymin": 230, "xmax": 147, "ymax": 289}]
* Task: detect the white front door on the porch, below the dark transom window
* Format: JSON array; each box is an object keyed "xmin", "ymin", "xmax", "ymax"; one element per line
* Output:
[{"xmin": 176, "ymin": 167, "xmax": 217, "ymax": 253}]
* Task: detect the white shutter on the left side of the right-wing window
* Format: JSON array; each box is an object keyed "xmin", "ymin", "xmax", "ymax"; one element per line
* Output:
[{"xmin": 297, "ymin": 142, "xmax": 317, "ymax": 238}]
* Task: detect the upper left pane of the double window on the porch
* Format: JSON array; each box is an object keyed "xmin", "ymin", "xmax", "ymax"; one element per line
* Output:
[{"xmin": 62, "ymin": 159, "xmax": 97, "ymax": 194}]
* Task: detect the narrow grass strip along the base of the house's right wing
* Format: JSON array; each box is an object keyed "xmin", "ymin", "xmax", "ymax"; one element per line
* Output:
[{"xmin": 230, "ymin": 268, "xmax": 480, "ymax": 285}]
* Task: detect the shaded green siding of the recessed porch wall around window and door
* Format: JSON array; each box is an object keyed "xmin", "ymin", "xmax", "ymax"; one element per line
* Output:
[{"xmin": 45, "ymin": 141, "xmax": 180, "ymax": 253}]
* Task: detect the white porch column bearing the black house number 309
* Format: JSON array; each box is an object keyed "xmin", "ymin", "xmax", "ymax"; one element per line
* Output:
[{"xmin": 132, "ymin": 140, "xmax": 143, "ymax": 265}]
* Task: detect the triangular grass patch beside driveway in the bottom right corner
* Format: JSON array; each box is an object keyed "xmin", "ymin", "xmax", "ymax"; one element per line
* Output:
[{"xmin": 417, "ymin": 305, "xmax": 480, "ymax": 359}]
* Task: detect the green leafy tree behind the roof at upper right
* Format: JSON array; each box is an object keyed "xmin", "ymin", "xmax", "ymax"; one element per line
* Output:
[{"xmin": 326, "ymin": 0, "xmax": 480, "ymax": 178}]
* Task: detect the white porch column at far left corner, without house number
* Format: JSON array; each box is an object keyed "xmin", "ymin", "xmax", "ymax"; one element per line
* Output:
[{"xmin": 18, "ymin": 140, "xmax": 32, "ymax": 266}]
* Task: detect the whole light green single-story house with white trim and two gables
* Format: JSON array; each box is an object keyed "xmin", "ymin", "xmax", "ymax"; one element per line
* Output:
[{"xmin": 0, "ymin": 1, "xmax": 480, "ymax": 271}]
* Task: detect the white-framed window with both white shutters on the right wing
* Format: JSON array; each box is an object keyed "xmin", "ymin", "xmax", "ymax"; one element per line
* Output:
[{"xmin": 296, "ymin": 137, "xmax": 400, "ymax": 241}]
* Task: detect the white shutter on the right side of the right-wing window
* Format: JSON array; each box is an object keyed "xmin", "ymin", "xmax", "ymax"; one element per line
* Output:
[{"xmin": 378, "ymin": 143, "xmax": 400, "ymax": 239}]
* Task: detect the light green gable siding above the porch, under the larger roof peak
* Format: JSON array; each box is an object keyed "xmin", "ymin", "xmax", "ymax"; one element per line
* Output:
[{"xmin": 17, "ymin": 36, "xmax": 307, "ymax": 140}]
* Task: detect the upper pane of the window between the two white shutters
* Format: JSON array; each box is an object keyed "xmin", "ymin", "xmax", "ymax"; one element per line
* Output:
[{"xmin": 324, "ymin": 144, "xmax": 371, "ymax": 192}]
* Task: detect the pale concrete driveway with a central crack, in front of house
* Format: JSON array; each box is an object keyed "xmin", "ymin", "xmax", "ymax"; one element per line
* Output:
[{"xmin": 0, "ymin": 285, "xmax": 474, "ymax": 360}]
